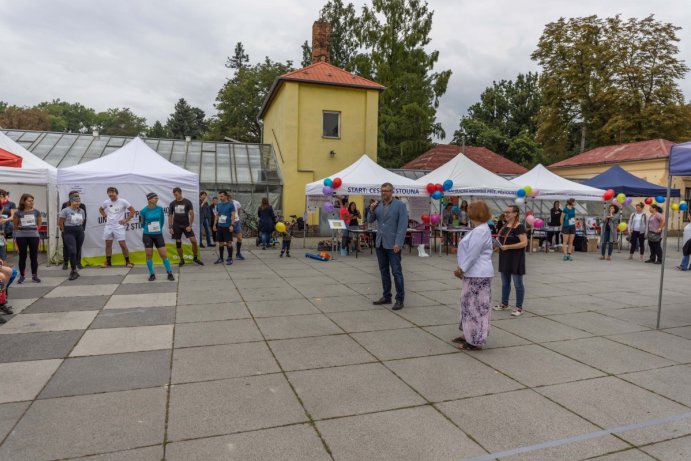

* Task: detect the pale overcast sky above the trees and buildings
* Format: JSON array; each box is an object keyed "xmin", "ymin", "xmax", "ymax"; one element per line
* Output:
[{"xmin": 0, "ymin": 0, "xmax": 691, "ymax": 142}]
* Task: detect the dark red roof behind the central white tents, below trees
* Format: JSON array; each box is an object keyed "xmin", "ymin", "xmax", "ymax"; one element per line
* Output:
[{"xmin": 401, "ymin": 144, "xmax": 528, "ymax": 174}]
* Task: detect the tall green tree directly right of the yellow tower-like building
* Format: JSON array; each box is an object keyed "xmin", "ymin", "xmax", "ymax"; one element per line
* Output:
[{"xmin": 355, "ymin": 0, "xmax": 451, "ymax": 166}]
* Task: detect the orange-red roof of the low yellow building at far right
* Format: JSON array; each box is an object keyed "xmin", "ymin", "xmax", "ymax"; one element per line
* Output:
[{"xmin": 548, "ymin": 139, "xmax": 674, "ymax": 168}]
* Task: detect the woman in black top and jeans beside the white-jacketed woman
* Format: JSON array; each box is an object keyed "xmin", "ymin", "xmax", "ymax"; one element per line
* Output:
[{"xmin": 492, "ymin": 205, "xmax": 528, "ymax": 317}]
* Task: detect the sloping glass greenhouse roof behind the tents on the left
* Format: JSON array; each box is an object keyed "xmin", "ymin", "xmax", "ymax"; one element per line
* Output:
[{"xmin": 3, "ymin": 130, "xmax": 283, "ymax": 188}]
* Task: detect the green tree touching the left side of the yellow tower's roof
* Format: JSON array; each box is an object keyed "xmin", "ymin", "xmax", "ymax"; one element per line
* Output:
[{"xmin": 214, "ymin": 57, "xmax": 293, "ymax": 142}]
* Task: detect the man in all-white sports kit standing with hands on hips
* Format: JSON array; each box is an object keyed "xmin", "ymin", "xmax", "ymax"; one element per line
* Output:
[{"xmin": 98, "ymin": 186, "xmax": 135, "ymax": 267}]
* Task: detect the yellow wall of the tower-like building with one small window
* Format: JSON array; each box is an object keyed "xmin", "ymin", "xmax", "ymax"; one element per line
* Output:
[{"xmin": 263, "ymin": 82, "xmax": 379, "ymax": 224}]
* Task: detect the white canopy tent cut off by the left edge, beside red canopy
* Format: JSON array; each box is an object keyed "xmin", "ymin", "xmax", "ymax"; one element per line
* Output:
[{"xmin": 0, "ymin": 132, "xmax": 60, "ymax": 260}]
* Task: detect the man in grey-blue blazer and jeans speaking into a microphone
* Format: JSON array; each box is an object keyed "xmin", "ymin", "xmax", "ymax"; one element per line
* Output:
[{"xmin": 368, "ymin": 183, "xmax": 408, "ymax": 311}]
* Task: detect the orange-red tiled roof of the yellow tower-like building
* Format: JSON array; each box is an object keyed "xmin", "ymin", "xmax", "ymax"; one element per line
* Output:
[{"xmin": 257, "ymin": 61, "xmax": 386, "ymax": 119}]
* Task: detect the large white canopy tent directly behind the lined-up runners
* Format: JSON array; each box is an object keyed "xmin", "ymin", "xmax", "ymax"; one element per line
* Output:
[{"xmin": 58, "ymin": 138, "xmax": 199, "ymax": 265}]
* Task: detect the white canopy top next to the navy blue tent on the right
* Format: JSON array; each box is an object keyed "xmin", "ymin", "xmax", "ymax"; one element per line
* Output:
[{"xmin": 511, "ymin": 164, "xmax": 605, "ymax": 202}]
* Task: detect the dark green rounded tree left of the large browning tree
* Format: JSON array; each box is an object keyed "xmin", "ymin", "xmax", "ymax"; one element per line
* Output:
[{"xmin": 452, "ymin": 72, "xmax": 542, "ymax": 167}]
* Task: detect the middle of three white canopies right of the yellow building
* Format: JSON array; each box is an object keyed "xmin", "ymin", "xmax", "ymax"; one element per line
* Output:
[{"xmin": 417, "ymin": 154, "xmax": 517, "ymax": 197}]
